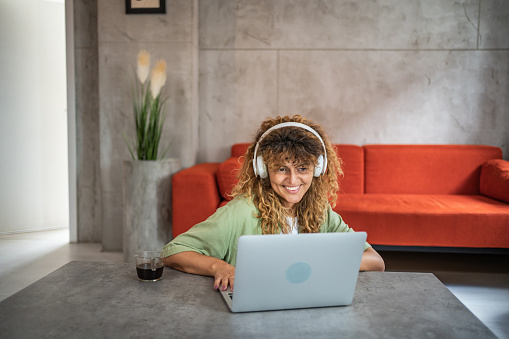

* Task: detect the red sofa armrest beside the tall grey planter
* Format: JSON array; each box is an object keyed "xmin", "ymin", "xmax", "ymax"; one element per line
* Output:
[{"xmin": 172, "ymin": 163, "xmax": 221, "ymax": 238}]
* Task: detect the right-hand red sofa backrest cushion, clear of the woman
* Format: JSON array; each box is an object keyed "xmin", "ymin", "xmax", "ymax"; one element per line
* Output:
[{"xmin": 364, "ymin": 145, "xmax": 502, "ymax": 194}]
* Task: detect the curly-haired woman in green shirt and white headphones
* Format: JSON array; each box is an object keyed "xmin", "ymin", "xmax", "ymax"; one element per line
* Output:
[{"xmin": 163, "ymin": 115, "xmax": 385, "ymax": 290}]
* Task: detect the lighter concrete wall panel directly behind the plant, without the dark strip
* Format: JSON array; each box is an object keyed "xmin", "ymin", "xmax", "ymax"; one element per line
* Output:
[{"xmin": 98, "ymin": 0, "xmax": 197, "ymax": 250}]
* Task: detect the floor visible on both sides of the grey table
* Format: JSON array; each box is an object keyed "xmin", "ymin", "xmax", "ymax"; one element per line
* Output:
[{"xmin": 0, "ymin": 229, "xmax": 509, "ymax": 339}]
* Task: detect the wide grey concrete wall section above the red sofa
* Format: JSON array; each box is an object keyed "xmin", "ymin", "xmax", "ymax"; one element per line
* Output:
[{"xmin": 199, "ymin": 0, "xmax": 509, "ymax": 161}]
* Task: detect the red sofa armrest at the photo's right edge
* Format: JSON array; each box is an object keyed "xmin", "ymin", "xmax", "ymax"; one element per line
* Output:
[{"xmin": 480, "ymin": 159, "xmax": 509, "ymax": 203}]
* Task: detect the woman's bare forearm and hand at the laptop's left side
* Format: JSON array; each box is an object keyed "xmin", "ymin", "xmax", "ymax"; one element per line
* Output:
[{"xmin": 164, "ymin": 251, "xmax": 235, "ymax": 291}]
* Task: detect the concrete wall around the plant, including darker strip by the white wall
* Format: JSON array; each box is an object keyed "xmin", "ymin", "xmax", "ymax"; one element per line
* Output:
[{"xmin": 75, "ymin": 0, "xmax": 198, "ymax": 250}]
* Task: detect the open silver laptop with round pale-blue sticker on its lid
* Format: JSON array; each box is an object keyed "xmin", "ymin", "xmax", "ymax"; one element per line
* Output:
[{"xmin": 220, "ymin": 232, "xmax": 366, "ymax": 312}]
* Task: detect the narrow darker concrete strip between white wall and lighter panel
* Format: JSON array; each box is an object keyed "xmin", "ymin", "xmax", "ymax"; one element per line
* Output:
[{"xmin": 73, "ymin": 0, "xmax": 102, "ymax": 242}]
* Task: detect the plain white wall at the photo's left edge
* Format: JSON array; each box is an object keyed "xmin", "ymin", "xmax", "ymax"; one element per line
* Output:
[{"xmin": 0, "ymin": 0, "xmax": 69, "ymax": 233}]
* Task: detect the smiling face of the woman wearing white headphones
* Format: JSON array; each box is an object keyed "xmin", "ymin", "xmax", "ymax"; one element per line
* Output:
[{"xmin": 268, "ymin": 158, "xmax": 314, "ymax": 210}]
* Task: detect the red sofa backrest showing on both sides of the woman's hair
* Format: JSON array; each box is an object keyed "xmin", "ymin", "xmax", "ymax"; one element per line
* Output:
[{"xmin": 217, "ymin": 143, "xmax": 364, "ymax": 200}]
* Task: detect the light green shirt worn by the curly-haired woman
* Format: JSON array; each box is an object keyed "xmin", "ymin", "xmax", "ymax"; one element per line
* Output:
[{"xmin": 162, "ymin": 197, "xmax": 371, "ymax": 266}]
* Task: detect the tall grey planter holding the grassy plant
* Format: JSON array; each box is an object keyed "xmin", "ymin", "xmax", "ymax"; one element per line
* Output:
[{"xmin": 123, "ymin": 159, "xmax": 180, "ymax": 262}]
